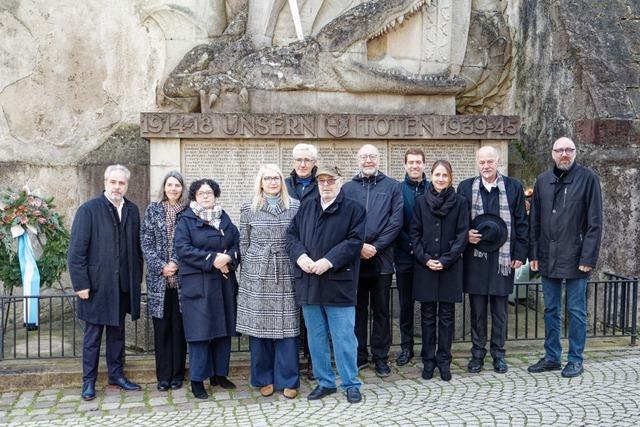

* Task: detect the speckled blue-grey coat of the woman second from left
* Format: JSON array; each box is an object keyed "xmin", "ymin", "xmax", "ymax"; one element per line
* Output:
[{"xmin": 140, "ymin": 202, "xmax": 180, "ymax": 319}]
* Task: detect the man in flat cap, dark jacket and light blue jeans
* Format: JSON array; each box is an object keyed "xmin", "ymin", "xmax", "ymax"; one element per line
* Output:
[{"xmin": 286, "ymin": 166, "xmax": 365, "ymax": 403}]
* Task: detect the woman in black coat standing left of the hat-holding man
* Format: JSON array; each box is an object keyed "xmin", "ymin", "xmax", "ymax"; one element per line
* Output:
[{"xmin": 411, "ymin": 160, "xmax": 469, "ymax": 381}]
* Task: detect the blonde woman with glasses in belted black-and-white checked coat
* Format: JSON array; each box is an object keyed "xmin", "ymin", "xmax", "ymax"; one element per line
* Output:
[{"xmin": 236, "ymin": 164, "xmax": 300, "ymax": 399}]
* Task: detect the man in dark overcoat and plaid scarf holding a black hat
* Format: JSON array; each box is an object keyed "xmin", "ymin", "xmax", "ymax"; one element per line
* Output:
[{"xmin": 458, "ymin": 146, "xmax": 529, "ymax": 374}]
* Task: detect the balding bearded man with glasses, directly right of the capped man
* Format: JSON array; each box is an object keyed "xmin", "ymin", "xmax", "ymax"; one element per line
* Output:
[{"xmin": 343, "ymin": 144, "xmax": 403, "ymax": 377}]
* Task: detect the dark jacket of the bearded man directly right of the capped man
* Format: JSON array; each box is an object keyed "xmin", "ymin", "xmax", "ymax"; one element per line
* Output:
[{"xmin": 342, "ymin": 172, "xmax": 403, "ymax": 275}]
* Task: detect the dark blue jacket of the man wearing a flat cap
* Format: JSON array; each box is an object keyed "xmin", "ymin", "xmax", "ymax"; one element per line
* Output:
[{"xmin": 286, "ymin": 191, "xmax": 365, "ymax": 306}]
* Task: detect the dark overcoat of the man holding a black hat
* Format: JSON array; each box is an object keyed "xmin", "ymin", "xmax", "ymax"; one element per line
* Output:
[{"xmin": 458, "ymin": 175, "xmax": 529, "ymax": 296}]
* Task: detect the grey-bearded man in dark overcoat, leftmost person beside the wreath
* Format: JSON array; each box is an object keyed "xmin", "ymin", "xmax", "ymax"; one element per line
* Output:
[{"xmin": 68, "ymin": 165, "xmax": 142, "ymax": 400}]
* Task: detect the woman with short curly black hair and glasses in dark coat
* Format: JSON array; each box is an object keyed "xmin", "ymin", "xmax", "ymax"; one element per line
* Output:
[{"xmin": 174, "ymin": 179, "xmax": 240, "ymax": 399}]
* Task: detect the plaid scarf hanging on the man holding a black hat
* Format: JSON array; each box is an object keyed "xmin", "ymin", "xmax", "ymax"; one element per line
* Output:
[{"xmin": 471, "ymin": 172, "xmax": 511, "ymax": 276}]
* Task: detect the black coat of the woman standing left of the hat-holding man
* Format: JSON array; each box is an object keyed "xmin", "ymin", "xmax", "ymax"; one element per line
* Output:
[{"xmin": 411, "ymin": 191, "xmax": 469, "ymax": 302}]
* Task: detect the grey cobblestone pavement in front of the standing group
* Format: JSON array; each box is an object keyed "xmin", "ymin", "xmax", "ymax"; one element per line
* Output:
[{"xmin": 0, "ymin": 349, "xmax": 640, "ymax": 427}]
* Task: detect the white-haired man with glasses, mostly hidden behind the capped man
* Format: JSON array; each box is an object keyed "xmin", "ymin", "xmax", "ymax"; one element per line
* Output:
[{"xmin": 285, "ymin": 144, "xmax": 318, "ymax": 203}]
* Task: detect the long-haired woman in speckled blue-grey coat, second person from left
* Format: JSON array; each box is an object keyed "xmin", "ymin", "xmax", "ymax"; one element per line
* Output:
[{"xmin": 140, "ymin": 171, "xmax": 187, "ymax": 391}]
